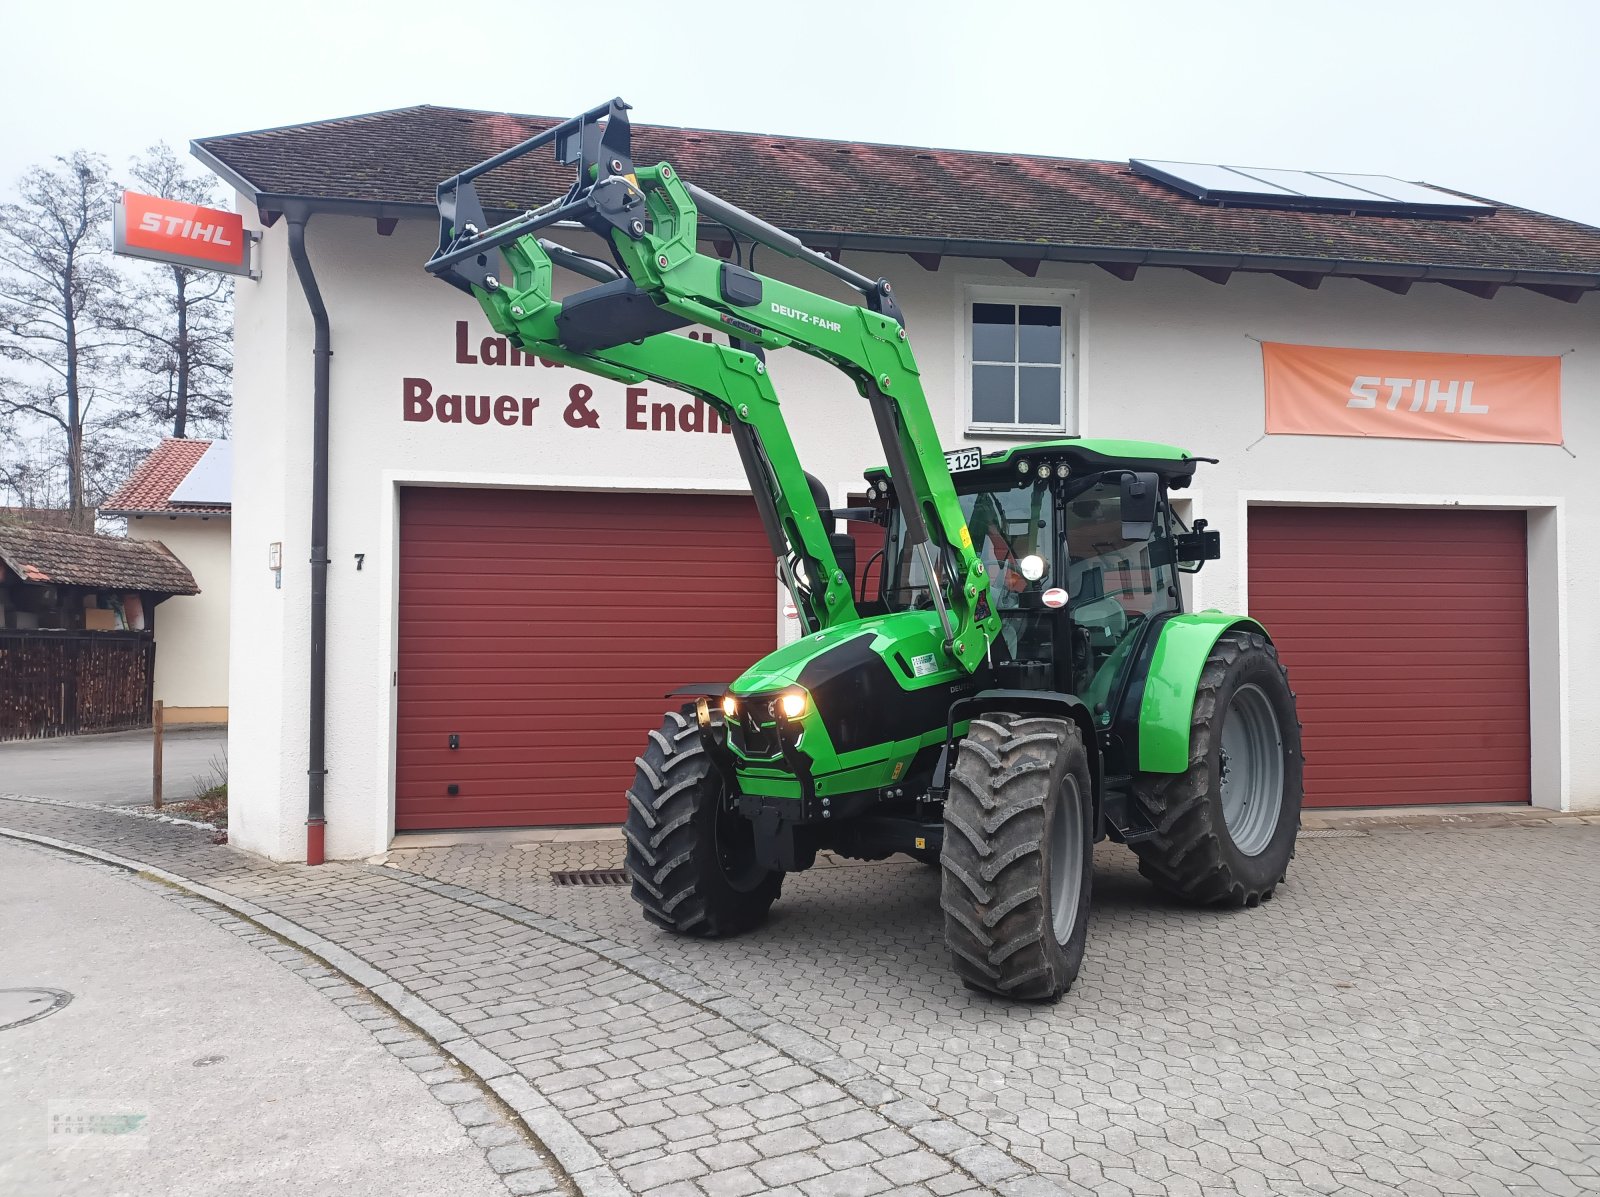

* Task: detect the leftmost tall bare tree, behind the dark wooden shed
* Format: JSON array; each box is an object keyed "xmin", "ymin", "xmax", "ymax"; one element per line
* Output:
[{"xmin": 0, "ymin": 150, "xmax": 123, "ymax": 530}]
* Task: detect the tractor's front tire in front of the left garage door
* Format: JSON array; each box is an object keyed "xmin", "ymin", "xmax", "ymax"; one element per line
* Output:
[{"xmin": 622, "ymin": 707, "xmax": 784, "ymax": 939}]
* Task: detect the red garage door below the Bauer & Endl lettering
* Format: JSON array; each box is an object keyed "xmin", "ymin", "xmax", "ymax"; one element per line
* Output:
[{"xmin": 395, "ymin": 488, "xmax": 776, "ymax": 831}]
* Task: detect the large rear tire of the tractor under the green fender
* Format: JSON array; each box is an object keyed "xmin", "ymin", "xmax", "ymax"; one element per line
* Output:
[{"xmin": 1130, "ymin": 631, "xmax": 1304, "ymax": 906}]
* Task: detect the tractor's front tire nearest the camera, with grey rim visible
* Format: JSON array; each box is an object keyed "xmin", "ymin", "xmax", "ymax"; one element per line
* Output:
[{"xmin": 939, "ymin": 712, "xmax": 1094, "ymax": 1002}]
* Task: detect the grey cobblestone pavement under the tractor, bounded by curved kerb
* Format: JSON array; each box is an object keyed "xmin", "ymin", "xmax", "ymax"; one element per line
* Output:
[{"xmin": 0, "ymin": 802, "xmax": 1600, "ymax": 1197}]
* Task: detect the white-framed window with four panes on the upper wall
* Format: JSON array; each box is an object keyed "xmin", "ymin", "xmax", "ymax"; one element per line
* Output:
[{"xmin": 962, "ymin": 286, "xmax": 1078, "ymax": 435}]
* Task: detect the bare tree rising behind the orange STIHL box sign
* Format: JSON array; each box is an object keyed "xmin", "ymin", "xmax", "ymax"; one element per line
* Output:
[{"xmin": 117, "ymin": 142, "xmax": 234, "ymax": 437}]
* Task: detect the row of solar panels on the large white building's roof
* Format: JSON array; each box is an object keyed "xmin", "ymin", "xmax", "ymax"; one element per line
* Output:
[{"xmin": 1128, "ymin": 158, "xmax": 1494, "ymax": 216}]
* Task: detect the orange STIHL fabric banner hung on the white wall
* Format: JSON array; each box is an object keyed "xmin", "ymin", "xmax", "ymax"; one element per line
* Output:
[{"xmin": 1261, "ymin": 341, "xmax": 1562, "ymax": 445}]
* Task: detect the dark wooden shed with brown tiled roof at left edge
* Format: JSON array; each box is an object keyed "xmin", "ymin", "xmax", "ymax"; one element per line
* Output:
[{"xmin": 0, "ymin": 525, "xmax": 198, "ymax": 739}]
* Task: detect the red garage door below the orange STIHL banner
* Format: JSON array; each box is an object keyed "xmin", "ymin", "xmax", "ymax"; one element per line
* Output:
[{"xmin": 1250, "ymin": 507, "xmax": 1528, "ymax": 807}]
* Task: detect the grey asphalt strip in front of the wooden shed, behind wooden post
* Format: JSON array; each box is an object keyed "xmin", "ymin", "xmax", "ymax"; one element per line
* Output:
[{"xmin": 0, "ymin": 727, "xmax": 227, "ymax": 807}]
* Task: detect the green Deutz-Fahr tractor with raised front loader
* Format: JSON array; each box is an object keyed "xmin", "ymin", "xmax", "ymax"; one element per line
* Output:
[{"xmin": 427, "ymin": 101, "xmax": 1302, "ymax": 1000}]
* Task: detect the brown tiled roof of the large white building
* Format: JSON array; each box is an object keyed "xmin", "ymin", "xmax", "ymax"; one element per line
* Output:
[{"xmin": 195, "ymin": 106, "xmax": 1600, "ymax": 286}]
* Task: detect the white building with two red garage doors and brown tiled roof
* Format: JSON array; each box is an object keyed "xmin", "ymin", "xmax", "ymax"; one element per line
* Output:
[{"xmin": 196, "ymin": 107, "xmax": 1600, "ymax": 859}]
